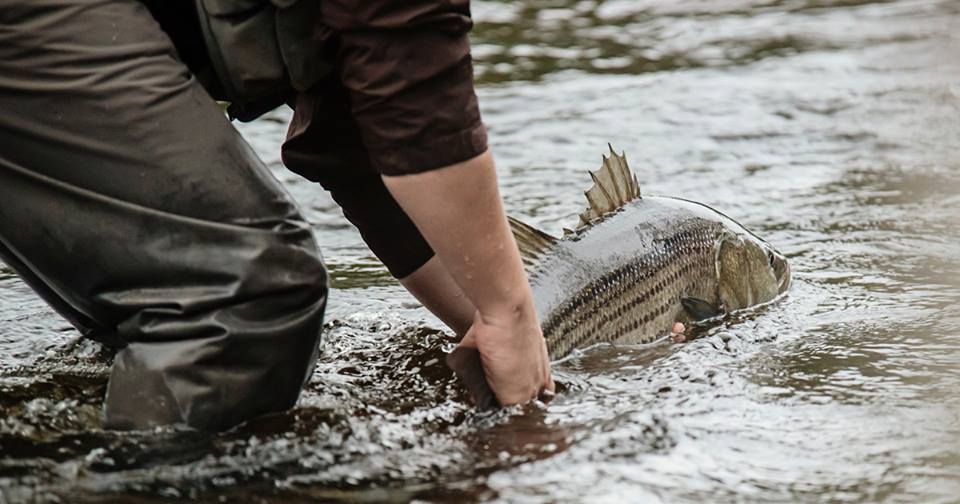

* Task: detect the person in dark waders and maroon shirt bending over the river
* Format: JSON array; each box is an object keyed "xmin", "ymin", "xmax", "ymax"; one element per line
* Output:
[{"xmin": 0, "ymin": 0, "xmax": 553, "ymax": 429}]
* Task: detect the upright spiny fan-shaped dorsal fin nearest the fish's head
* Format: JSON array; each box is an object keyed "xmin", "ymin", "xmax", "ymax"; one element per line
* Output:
[{"xmin": 577, "ymin": 144, "xmax": 640, "ymax": 229}]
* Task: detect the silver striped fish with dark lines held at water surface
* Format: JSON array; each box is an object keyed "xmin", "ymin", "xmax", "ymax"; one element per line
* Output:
[{"xmin": 510, "ymin": 147, "xmax": 790, "ymax": 360}]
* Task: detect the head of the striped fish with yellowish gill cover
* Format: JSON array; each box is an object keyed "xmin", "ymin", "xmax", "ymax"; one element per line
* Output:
[{"xmin": 714, "ymin": 229, "xmax": 790, "ymax": 312}]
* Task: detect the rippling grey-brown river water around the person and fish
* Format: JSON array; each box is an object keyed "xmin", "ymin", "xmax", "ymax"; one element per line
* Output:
[{"xmin": 0, "ymin": 0, "xmax": 960, "ymax": 503}]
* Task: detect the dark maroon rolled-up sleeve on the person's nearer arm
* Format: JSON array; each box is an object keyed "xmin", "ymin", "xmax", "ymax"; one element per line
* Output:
[{"xmin": 321, "ymin": 0, "xmax": 487, "ymax": 175}]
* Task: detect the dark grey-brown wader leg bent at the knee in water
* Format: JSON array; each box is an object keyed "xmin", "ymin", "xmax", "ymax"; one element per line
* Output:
[{"xmin": 0, "ymin": 0, "xmax": 327, "ymax": 429}]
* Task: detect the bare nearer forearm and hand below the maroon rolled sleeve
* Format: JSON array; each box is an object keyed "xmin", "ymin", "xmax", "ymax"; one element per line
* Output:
[{"xmin": 384, "ymin": 153, "xmax": 554, "ymax": 404}]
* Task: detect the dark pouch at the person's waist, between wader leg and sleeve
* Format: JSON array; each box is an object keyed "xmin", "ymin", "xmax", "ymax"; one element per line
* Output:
[{"xmin": 195, "ymin": 0, "xmax": 331, "ymax": 122}]
